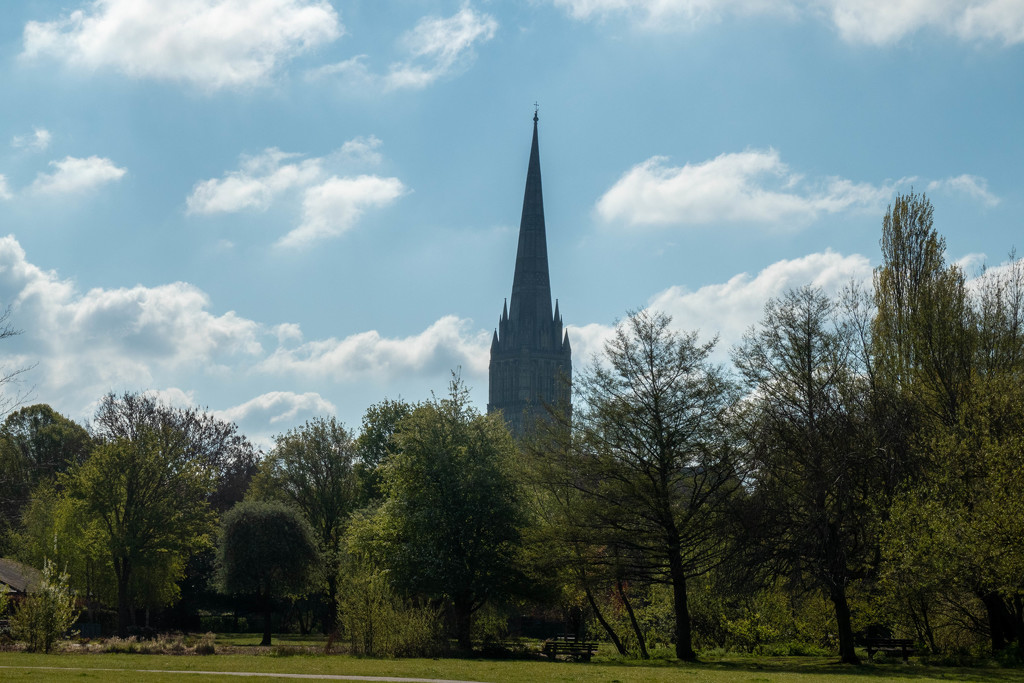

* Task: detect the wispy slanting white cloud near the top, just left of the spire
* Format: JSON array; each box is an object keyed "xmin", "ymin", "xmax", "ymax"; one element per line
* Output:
[{"xmin": 310, "ymin": 5, "xmax": 498, "ymax": 91}]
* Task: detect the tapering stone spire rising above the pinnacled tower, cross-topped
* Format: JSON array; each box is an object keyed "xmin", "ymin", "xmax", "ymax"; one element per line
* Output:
[{"xmin": 509, "ymin": 112, "xmax": 552, "ymax": 340}]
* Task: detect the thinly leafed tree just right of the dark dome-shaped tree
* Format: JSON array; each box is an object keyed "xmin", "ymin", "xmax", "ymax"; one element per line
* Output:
[{"xmin": 250, "ymin": 418, "xmax": 358, "ymax": 633}]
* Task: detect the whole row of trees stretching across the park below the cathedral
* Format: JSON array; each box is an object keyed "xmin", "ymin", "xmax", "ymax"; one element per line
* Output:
[{"xmin": 0, "ymin": 194, "xmax": 1024, "ymax": 663}]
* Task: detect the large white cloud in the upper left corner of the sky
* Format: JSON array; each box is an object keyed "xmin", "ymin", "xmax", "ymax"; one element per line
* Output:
[{"xmin": 23, "ymin": 0, "xmax": 343, "ymax": 90}]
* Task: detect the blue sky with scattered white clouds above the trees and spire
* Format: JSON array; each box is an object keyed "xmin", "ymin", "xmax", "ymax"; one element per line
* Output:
[{"xmin": 0, "ymin": 0, "xmax": 1024, "ymax": 443}]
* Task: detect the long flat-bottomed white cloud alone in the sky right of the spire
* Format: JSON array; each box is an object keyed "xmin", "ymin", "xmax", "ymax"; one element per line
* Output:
[{"xmin": 596, "ymin": 150, "xmax": 892, "ymax": 226}]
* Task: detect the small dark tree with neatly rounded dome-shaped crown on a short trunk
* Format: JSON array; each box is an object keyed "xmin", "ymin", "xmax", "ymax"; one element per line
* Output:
[{"xmin": 217, "ymin": 501, "xmax": 318, "ymax": 645}]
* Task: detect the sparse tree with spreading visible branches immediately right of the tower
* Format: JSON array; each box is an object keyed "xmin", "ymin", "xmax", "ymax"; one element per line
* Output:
[{"xmin": 562, "ymin": 311, "xmax": 739, "ymax": 660}]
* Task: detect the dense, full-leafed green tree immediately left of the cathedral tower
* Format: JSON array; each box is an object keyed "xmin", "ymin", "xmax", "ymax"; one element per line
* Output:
[{"xmin": 375, "ymin": 378, "xmax": 523, "ymax": 649}]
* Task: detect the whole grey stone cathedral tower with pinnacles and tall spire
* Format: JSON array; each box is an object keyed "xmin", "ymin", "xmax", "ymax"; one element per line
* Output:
[{"xmin": 487, "ymin": 112, "xmax": 572, "ymax": 437}]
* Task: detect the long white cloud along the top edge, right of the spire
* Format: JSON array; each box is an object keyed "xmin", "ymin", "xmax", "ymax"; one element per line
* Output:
[{"xmin": 552, "ymin": 0, "xmax": 1024, "ymax": 45}]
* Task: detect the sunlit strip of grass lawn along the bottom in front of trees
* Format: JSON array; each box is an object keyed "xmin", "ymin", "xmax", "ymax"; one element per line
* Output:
[{"xmin": 0, "ymin": 651, "xmax": 1024, "ymax": 683}]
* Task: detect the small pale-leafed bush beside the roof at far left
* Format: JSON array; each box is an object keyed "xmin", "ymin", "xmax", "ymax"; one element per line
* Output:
[{"xmin": 10, "ymin": 561, "xmax": 78, "ymax": 652}]
